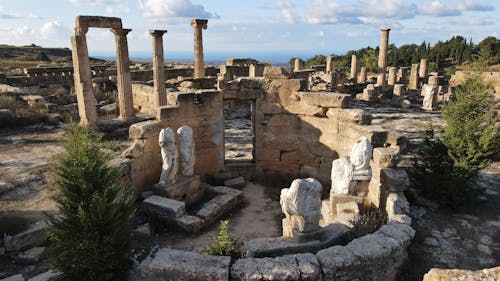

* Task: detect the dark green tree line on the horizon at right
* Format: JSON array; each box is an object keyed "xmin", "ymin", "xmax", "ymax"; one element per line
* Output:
[{"xmin": 289, "ymin": 36, "xmax": 500, "ymax": 72}]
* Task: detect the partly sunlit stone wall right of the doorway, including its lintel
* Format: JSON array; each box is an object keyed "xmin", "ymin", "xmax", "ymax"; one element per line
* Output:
[{"xmin": 220, "ymin": 73, "xmax": 398, "ymax": 184}]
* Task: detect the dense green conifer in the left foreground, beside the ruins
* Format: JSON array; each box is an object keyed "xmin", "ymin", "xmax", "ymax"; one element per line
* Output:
[{"xmin": 47, "ymin": 124, "xmax": 134, "ymax": 281}]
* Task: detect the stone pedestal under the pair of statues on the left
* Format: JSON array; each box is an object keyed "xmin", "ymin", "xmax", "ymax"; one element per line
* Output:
[{"xmin": 153, "ymin": 175, "xmax": 203, "ymax": 206}]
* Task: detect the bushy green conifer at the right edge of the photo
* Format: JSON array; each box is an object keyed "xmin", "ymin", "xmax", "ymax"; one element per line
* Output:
[{"xmin": 443, "ymin": 77, "xmax": 500, "ymax": 179}]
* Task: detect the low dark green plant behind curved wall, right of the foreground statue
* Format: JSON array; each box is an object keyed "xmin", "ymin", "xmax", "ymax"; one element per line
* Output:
[{"xmin": 348, "ymin": 207, "xmax": 387, "ymax": 241}]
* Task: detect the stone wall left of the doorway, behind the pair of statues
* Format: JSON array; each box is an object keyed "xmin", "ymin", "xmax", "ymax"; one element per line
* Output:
[{"xmin": 125, "ymin": 90, "xmax": 224, "ymax": 191}]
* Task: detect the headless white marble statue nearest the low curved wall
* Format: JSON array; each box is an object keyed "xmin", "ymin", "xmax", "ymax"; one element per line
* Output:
[{"xmin": 280, "ymin": 178, "xmax": 323, "ymax": 232}]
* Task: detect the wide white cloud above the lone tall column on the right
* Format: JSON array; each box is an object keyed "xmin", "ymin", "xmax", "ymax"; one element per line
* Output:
[{"xmin": 307, "ymin": 0, "xmax": 418, "ymax": 24}]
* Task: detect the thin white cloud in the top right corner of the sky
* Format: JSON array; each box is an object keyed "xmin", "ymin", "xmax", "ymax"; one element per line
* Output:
[{"xmin": 420, "ymin": 0, "xmax": 494, "ymax": 16}]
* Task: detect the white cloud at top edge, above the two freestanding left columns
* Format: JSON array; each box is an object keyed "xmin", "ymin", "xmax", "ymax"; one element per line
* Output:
[{"xmin": 139, "ymin": 0, "xmax": 219, "ymax": 21}]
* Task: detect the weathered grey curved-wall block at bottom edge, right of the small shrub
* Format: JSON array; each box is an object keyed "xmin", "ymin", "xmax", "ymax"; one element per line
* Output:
[{"xmin": 231, "ymin": 254, "xmax": 322, "ymax": 281}]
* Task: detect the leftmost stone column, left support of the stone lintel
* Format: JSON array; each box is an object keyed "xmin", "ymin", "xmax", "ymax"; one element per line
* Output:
[{"xmin": 71, "ymin": 27, "xmax": 97, "ymax": 125}]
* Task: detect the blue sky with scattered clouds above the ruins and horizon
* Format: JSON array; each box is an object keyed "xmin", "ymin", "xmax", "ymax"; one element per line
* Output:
[{"xmin": 0, "ymin": 0, "xmax": 500, "ymax": 60}]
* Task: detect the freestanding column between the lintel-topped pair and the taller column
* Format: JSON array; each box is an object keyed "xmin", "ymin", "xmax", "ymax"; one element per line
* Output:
[{"xmin": 149, "ymin": 30, "xmax": 167, "ymax": 107}]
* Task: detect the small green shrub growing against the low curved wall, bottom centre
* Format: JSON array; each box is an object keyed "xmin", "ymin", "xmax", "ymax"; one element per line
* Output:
[{"xmin": 203, "ymin": 220, "xmax": 243, "ymax": 260}]
